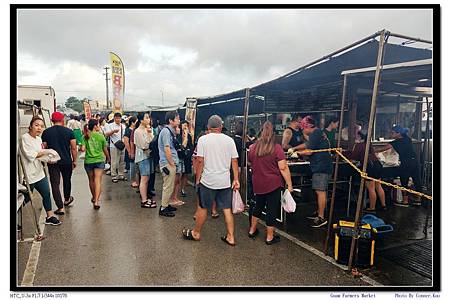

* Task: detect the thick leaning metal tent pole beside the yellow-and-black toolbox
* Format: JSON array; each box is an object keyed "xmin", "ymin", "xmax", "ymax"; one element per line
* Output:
[{"xmin": 348, "ymin": 30, "xmax": 387, "ymax": 271}]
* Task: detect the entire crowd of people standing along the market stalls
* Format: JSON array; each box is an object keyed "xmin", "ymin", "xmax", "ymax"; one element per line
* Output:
[{"xmin": 20, "ymin": 111, "xmax": 421, "ymax": 246}]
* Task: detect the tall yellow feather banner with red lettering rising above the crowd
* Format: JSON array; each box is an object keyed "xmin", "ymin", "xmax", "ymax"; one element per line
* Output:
[{"xmin": 109, "ymin": 52, "xmax": 125, "ymax": 113}]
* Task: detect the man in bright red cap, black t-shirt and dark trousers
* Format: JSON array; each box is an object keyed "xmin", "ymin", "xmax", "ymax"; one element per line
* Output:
[{"xmin": 42, "ymin": 111, "xmax": 78, "ymax": 215}]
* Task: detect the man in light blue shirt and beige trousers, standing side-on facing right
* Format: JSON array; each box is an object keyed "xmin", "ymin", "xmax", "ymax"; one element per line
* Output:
[{"xmin": 158, "ymin": 111, "xmax": 180, "ymax": 217}]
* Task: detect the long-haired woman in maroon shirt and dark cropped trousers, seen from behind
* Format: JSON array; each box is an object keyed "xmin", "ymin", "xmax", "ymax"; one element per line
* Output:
[{"xmin": 248, "ymin": 121, "xmax": 292, "ymax": 245}]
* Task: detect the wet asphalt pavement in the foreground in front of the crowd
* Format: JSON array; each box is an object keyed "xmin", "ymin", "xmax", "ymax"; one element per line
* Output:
[{"xmin": 17, "ymin": 162, "xmax": 368, "ymax": 287}]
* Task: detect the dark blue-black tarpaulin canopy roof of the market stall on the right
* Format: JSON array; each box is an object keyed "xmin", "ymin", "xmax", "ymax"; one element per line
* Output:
[{"xmin": 188, "ymin": 38, "xmax": 432, "ymax": 126}]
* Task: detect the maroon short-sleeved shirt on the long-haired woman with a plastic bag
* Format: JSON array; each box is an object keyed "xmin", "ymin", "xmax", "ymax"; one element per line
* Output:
[{"xmin": 248, "ymin": 144, "xmax": 286, "ymax": 194}]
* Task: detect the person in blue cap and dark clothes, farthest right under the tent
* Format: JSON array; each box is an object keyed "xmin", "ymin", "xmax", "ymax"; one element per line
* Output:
[{"xmin": 375, "ymin": 125, "xmax": 422, "ymax": 207}]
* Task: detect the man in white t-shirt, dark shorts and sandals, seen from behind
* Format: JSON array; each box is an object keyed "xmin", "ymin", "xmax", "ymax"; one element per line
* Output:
[{"xmin": 183, "ymin": 115, "xmax": 239, "ymax": 246}]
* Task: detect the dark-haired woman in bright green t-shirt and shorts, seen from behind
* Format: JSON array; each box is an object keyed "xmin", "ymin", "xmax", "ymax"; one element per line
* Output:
[{"xmin": 81, "ymin": 119, "xmax": 110, "ymax": 209}]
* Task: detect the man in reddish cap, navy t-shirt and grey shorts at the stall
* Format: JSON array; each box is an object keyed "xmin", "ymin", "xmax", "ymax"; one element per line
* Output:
[{"xmin": 298, "ymin": 116, "xmax": 333, "ymax": 228}]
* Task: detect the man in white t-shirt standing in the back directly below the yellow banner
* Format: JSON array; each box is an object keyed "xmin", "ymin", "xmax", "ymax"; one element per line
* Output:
[{"xmin": 104, "ymin": 112, "xmax": 127, "ymax": 183}]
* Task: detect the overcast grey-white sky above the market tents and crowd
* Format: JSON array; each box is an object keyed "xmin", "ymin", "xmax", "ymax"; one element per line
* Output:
[{"xmin": 17, "ymin": 9, "xmax": 432, "ymax": 106}]
